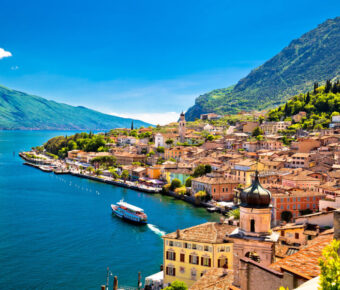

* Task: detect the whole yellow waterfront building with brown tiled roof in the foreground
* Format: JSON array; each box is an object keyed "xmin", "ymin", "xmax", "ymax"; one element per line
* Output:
[{"xmin": 163, "ymin": 222, "xmax": 235, "ymax": 287}]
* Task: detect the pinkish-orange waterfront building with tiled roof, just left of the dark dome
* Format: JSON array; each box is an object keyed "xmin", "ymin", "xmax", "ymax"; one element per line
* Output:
[{"xmin": 191, "ymin": 176, "xmax": 239, "ymax": 201}]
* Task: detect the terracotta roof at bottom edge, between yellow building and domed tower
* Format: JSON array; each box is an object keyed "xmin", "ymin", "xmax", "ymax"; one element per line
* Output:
[{"xmin": 189, "ymin": 268, "xmax": 234, "ymax": 290}]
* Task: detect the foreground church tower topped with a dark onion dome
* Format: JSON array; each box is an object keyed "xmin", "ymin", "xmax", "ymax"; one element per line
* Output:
[{"xmin": 229, "ymin": 171, "xmax": 279, "ymax": 288}]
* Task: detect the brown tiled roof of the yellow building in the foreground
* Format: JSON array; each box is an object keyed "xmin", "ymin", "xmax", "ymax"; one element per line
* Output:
[{"xmin": 163, "ymin": 222, "xmax": 236, "ymax": 244}]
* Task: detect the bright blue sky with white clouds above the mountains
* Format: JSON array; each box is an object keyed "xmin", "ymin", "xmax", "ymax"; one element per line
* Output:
[{"xmin": 0, "ymin": 0, "xmax": 340, "ymax": 124}]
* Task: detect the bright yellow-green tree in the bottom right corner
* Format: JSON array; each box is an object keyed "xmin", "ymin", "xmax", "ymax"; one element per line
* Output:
[{"xmin": 319, "ymin": 240, "xmax": 340, "ymax": 290}]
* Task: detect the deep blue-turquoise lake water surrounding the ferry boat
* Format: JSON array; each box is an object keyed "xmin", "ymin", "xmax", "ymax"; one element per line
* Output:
[{"xmin": 0, "ymin": 131, "xmax": 218, "ymax": 289}]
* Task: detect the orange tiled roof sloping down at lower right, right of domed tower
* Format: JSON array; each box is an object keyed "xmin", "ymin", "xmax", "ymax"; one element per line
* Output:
[{"xmin": 269, "ymin": 235, "xmax": 333, "ymax": 277}]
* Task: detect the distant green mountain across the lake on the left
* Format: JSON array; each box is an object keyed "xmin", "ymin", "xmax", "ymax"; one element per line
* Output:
[{"xmin": 0, "ymin": 86, "xmax": 150, "ymax": 130}]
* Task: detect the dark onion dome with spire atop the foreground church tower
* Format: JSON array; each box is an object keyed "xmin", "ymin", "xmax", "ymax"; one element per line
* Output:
[{"xmin": 240, "ymin": 171, "xmax": 271, "ymax": 208}]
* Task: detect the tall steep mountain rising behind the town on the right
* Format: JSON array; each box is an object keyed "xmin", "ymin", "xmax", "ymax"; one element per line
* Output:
[{"xmin": 186, "ymin": 17, "xmax": 340, "ymax": 120}]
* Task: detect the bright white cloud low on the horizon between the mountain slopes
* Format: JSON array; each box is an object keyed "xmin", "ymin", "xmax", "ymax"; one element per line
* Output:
[{"xmin": 111, "ymin": 112, "xmax": 179, "ymax": 125}]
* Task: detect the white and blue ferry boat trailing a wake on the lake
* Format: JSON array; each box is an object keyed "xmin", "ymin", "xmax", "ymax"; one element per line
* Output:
[{"xmin": 111, "ymin": 200, "xmax": 148, "ymax": 224}]
